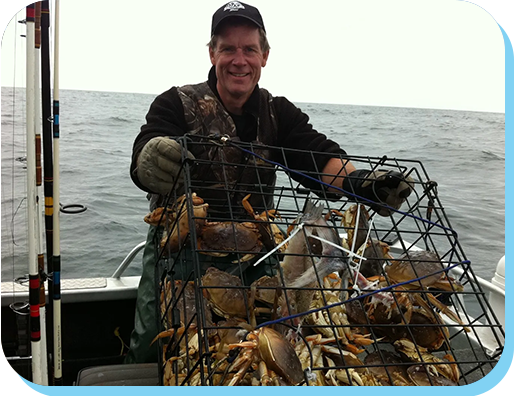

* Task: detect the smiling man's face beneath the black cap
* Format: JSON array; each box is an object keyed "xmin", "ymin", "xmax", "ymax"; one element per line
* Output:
[{"xmin": 209, "ymin": 25, "xmax": 268, "ymax": 108}]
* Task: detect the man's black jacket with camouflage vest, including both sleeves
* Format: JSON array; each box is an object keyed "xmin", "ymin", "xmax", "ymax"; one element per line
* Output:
[{"xmin": 131, "ymin": 68, "xmax": 345, "ymax": 210}]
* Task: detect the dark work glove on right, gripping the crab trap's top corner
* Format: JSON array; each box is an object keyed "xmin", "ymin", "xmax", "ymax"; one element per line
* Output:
[{"xmin": 343, "ymin": 169, "xmax": 414, "ymax": 216}]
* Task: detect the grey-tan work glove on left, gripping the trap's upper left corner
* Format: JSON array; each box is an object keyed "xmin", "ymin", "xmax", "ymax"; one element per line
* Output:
[{"xmin": 137, "ymin": 136, "xmax": 195, "ymax": 195}]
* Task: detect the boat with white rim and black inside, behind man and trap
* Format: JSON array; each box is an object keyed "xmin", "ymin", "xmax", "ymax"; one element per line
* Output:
[{"xmin": 1, "ymin": 246, "xmax": 505, "ymax": 386}]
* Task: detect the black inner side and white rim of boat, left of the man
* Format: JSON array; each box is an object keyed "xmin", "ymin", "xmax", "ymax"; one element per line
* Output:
[{"xmin": 1, "ymin": 277, "xmax": 141, "ymax": 386}]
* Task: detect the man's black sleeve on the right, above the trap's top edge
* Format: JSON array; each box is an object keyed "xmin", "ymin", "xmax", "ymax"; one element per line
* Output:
[{"xmin": 274, "ymin": 97, "xmax": 346, "ymax": 190}]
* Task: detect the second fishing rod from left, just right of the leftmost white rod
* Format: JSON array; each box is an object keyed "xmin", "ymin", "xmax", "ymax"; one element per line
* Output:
[{"xmin": 34, "ymin": 1, "xmax": 48, "ymax": 385}]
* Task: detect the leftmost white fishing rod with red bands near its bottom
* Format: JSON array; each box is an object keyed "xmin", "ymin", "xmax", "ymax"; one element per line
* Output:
[{"xmin": 26, "ymin": 4, "xmax": 42, "ymax": 384}]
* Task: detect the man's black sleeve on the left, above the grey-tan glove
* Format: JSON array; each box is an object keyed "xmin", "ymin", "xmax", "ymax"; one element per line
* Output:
[{"xmin": 130, "ymin": 87, "xmax": 187, "ymax": 192}]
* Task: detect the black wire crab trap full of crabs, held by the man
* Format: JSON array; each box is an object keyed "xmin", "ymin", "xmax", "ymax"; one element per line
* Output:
[{"xmin": 146, "ymin": 138, "xmax": 504, "ymax": 385}]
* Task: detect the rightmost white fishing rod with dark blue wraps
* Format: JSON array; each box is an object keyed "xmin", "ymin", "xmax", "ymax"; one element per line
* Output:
[{"xmin": 52, "ymin": 0, "xmax": 63, "ymax": 385}]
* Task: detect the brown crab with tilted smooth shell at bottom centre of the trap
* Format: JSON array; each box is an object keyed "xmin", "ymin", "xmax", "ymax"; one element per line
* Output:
[{"xmin": 228, "ymin": 326, "xmax": 304, "ymax": 385}]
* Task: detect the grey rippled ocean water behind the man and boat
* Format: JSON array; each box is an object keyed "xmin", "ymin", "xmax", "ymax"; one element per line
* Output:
[{"xmin": 1, "ymin": 87, "xmax": 505, "ymax": 281}]
